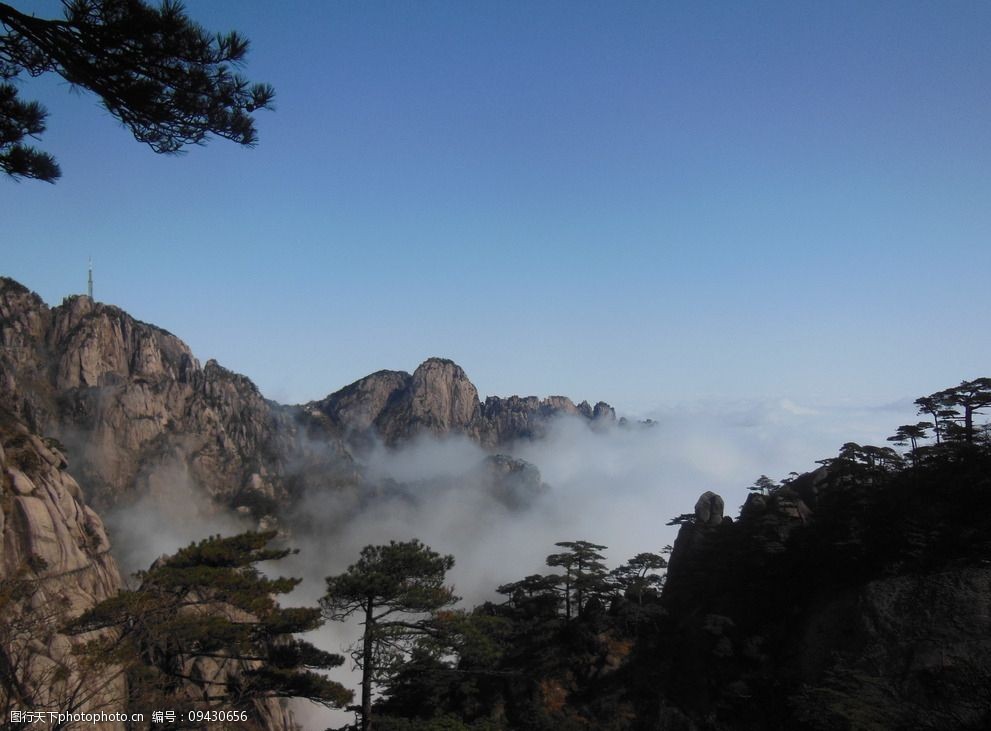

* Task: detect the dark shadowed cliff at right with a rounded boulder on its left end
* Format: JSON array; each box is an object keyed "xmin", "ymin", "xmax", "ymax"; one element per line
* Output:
[{"xmin": 658, "ymin": 448, "xmax": 991, "ymax": 731}]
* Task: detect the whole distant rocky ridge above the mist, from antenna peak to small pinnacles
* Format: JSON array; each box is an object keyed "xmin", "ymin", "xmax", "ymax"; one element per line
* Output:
[{"xmin": 0, "ymin": 277, "xmax": 615, "ymax": 512}]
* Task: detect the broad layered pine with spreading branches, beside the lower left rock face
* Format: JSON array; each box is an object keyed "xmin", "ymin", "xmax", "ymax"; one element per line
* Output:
[{"xmin": 70, "ymin": 531, "xmax": 352, "ymax": 711}]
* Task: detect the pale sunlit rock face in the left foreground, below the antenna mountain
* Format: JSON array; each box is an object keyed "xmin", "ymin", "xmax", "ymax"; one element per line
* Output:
[{"xmin": 0, "ymin": 413, "xmax": 125, "ymax": 731}]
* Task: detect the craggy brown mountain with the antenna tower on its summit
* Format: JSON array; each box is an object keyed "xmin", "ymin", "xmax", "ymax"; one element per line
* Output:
[{"xmin": 0, "ymin": 279, "xmax": 356, "ymax": 508}]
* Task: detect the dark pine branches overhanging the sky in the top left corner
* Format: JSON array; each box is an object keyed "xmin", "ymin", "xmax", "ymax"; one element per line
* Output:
[{"xmin": 0, "ymin": 0, "xmax": 275, "ymax": 182}]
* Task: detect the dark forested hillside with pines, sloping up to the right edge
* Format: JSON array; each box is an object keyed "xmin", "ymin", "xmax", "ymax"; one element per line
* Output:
[{"xmin": 332, "ymin": 378, "xmax": 991, "ymax": 731}]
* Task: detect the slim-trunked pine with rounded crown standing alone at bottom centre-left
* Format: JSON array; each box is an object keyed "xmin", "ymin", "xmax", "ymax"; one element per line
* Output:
[{"xmin": 320, "ymin": 540, "xmax": 458, "ymax": 731}]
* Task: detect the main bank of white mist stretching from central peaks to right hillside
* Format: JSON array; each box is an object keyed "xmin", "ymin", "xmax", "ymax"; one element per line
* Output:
[{"xmin": 290, "ymin": 401, "xmax": 911, "ymax": 603}]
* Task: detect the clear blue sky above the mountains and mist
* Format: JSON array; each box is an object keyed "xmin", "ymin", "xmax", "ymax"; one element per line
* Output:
[{"xmin": 0, "ymin": 0, "xmax": 991, "ymax": 412}]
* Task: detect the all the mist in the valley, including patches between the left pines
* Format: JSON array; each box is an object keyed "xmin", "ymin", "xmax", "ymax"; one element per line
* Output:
[{"xmin": 99, "ymin": 392, "xmax": 914, "ymax": 729}]
